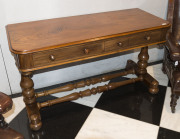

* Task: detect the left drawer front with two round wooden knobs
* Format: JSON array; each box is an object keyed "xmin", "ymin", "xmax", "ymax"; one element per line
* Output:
[{"xmin": 33, "ymin": 42, "xmax": 104, "ymax": 67}]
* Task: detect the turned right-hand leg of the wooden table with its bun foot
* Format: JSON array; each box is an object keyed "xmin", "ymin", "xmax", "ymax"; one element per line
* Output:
[{"xmin": 137, "ymin": 47, "xmax": 159, "ymax": 94}]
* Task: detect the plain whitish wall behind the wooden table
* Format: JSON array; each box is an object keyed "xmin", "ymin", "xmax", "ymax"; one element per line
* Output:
[{"xmin": 0, "ymin": 0, "xmax": 167, "ymax": 93}]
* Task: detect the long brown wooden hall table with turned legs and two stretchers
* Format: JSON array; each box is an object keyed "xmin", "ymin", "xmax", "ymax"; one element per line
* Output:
[{"xmin": 6, "ymin": 9, "xmax": 170, "ymax": 130}]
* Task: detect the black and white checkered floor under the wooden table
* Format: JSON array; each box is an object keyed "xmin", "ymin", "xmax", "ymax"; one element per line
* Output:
[{"xmin": 5, "ymin": 64, "xmax": 180, "ymax": 139}]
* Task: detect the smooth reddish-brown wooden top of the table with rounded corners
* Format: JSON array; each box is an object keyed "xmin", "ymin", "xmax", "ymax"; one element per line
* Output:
[{"xmin": 6, "ymin": 8, "xmax": 170, "ymax": 54}]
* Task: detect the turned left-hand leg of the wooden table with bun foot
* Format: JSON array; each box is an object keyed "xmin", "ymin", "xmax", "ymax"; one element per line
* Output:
[{"xmin": 20, "ymin": 72, "xmax": 42, "ymax": 131}]
